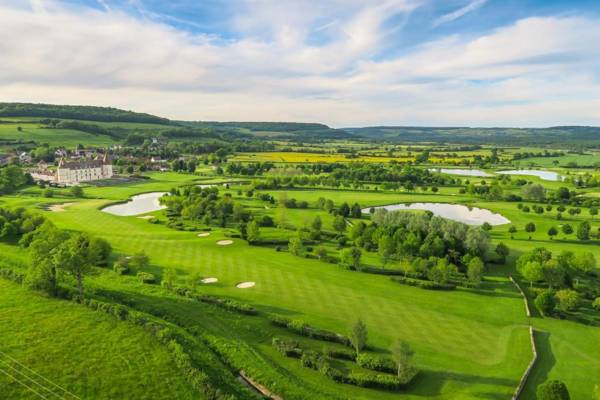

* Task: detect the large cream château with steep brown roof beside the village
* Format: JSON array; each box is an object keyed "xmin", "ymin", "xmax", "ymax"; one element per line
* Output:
[{"xmin": 56, "ymin": 154, "xmax": 113, "ymax": 185}]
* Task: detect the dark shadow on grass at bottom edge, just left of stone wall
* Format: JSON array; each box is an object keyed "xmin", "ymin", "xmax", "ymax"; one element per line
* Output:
[{"xmin": 410, "ymin": 370, "xmax": 518, "ymax": 399}]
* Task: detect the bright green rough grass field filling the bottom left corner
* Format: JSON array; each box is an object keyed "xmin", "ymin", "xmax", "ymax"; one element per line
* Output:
[{"xmin": 0, "ymin": 280, "xmax": 197, "ymax": 399}]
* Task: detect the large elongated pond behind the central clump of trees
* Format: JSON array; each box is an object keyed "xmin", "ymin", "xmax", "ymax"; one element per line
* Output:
[{"xmin": 363, "ymin": 203, "xmax": 510, "ymax": 225}]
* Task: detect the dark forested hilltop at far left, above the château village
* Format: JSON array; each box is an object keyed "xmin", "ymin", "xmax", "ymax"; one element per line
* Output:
[{"xmin": 0, "ymin": 103, "xmax": 171, "ymax": 125}]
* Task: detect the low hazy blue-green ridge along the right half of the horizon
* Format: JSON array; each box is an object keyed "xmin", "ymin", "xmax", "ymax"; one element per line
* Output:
[{"xmin": 344, "ymin": 126, "xmax": 600, "ymax": 146}]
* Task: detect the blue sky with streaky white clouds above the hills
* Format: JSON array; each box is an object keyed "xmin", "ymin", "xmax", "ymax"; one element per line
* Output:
[{"xmin": 0, "ymin": 0, "xmax": 600, "ymax": 127}]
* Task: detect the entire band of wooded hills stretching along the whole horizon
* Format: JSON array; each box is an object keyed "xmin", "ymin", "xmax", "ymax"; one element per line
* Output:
[{"xmin": 0, "ymin": 103, "xmax": 600, "ymax": 147}]
